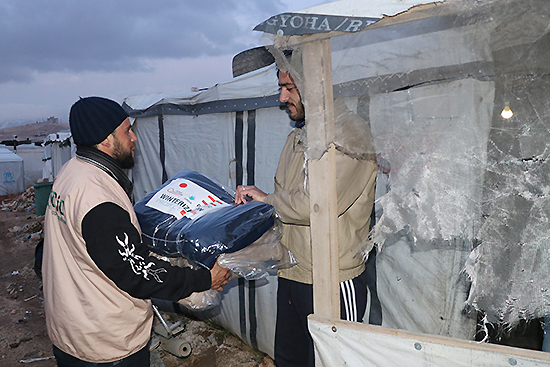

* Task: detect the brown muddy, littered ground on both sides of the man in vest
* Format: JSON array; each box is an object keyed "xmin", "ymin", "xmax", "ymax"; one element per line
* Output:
[{"xmin": 0, "ymin": 187, "xmax": 273, "ymax": 367}]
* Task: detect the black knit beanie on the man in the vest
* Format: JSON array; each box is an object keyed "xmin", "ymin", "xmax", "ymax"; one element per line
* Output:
[{"xmin": 69, "ymin": 97, "xmax": 128, "ymax": 146}]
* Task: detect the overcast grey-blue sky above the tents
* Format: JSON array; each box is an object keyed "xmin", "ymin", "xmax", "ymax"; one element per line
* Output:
[{"xmin": 0, "ymin": 0, "xmax": 330, "ymax": 128}]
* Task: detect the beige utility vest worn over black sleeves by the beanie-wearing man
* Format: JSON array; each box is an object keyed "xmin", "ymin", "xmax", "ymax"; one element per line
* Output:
[{"xmin": 42, "ymin": 158, "xmax": 153, "ymax": 363}]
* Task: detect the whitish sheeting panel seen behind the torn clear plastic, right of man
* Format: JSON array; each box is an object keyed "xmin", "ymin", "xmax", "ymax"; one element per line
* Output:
[{"xmin": 370, "ymin": 79, "xmax": 494, "ymax": 339}]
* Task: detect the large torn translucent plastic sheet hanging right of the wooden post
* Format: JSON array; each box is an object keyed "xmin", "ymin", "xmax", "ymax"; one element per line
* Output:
[{"xmin": 264, "ymin": 0, "xmax": 550, "ymax": 332}]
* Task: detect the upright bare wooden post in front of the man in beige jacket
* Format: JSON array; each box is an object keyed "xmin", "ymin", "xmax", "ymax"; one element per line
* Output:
[{"xmin": 300, "ymin": 39, "xmax": 340, "ymax": 318}]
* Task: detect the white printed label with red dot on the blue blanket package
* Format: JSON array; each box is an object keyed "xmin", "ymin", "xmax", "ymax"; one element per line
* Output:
[{"xmin": 146, "ymin": 178, "xmax": 230, "ymax": 219}]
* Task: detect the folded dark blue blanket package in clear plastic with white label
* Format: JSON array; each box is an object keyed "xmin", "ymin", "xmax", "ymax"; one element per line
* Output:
[{"xmin": 134, "ymin": 170, "xmax": 274, "ymax": 269}]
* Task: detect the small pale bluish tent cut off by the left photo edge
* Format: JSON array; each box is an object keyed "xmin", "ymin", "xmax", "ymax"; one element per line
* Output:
[{"xmin": 0, "ymin": 145, "xmax": 25, "ymax": 196}]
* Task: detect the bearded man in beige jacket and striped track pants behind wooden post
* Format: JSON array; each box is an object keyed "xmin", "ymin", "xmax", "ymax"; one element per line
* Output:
[{"xmin": 235, "ymin": 70, "xmax": 378, "ymax": 367}]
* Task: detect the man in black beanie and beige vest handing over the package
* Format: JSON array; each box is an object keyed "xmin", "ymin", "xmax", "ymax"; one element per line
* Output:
[{"xmin": 43, "ymin": 97, "xmax": 229, "ymax": 367}]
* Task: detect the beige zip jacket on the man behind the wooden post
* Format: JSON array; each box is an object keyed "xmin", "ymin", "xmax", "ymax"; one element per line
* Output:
[{"xmin": 265, "ymin": 127, "xmax": 378, "ymax": 284}]
